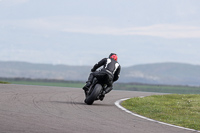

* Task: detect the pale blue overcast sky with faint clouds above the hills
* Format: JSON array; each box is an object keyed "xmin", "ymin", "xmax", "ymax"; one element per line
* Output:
[{"xmin": 0, "ymin": 0, "xmax": 200, "ymax": 66}]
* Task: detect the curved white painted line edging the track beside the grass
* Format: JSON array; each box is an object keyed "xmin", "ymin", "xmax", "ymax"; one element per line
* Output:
[{"xmin": 115, "ymin": 98, "xmax": 200, "ymax": 132}]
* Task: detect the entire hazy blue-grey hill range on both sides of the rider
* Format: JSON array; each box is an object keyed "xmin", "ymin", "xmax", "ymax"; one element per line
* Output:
[{"xmin": 0, "ymin": 61, "xmax": 200, "ymax": 86}]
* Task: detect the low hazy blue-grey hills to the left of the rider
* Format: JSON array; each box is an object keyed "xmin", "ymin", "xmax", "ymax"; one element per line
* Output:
[{"xmin": 0, "ymin": 62, "xmax": 91, "ymax": 81}]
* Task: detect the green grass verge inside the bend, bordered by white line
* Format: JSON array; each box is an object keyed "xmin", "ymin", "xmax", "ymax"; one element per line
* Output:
[{"xmin": 122, "ymin": 94, "xmax": 200, "ymax": 130}]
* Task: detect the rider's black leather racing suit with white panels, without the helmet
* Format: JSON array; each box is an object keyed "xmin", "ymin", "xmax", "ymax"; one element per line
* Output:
[{"xmin": 87, "ymin": 58, "xmax": 121, "ymax": 93}]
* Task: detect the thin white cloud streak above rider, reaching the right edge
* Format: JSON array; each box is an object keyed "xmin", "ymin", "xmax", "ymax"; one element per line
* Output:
[{"xmin": 63, "ymin": 24, "xmax": 200, "ymax": 39}]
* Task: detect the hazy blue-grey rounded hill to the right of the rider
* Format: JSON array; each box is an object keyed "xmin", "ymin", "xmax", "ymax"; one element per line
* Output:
[{"xmin": 121, "ymin": 63, "xmax": 200, "ymax": 85}]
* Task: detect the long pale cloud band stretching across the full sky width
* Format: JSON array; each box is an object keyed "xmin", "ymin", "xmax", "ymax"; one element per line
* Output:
[{"xmin": 0, "ymin": 17, "xmax": 200, "ymax": 39}]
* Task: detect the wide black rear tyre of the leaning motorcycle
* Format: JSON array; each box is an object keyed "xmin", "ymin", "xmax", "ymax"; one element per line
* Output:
[{"xmin": 85, "ymin": 84, "xmax": 102, "ymax": 105}]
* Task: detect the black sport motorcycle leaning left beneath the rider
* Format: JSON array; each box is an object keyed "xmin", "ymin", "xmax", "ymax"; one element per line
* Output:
[{"xmin": 85, "ymin": 75, "xmax": 108, "ymax": 105}]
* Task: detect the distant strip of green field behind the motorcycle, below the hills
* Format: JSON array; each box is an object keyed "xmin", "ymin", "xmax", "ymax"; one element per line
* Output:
[{"xmin": 0, "ymin": 79, "xmax": 200, "ymax": 94}]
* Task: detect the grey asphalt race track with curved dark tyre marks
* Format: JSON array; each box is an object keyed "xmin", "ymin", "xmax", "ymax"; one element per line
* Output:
[{"xmin": 0, "ymin": 84, "xmax": 197, "ymax": 133}]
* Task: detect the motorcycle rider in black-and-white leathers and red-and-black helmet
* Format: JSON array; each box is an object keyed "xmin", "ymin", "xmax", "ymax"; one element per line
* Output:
[{"xmin": 83, "ymin": 53, "xmax": 121, "ymax": 100}]
